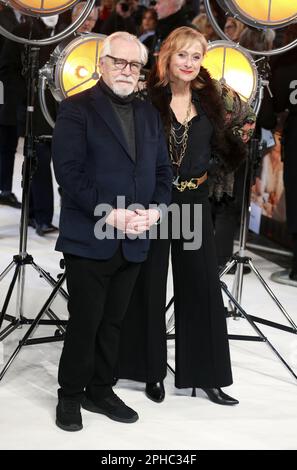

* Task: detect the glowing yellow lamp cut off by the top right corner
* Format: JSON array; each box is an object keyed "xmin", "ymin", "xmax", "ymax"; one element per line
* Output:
[{"xmin": 225, "ymin": 0, "xmax": 297, "ymax": 28}]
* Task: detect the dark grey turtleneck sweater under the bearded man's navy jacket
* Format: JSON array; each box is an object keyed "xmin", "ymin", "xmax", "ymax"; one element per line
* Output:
[{"xmin": 99, "ymin": 77, "xmax": 136, "ymax": 161}]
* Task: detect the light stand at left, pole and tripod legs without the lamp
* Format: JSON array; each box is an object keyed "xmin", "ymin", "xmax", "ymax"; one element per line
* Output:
[{"xmin": 0, "ymin": 46, "xmax": 68, "ymax": 380}]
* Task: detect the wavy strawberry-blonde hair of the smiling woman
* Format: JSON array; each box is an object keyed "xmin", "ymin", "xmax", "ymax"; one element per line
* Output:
[{"xmin": 156, "ymin": 26, "xmax": 207, "ymax": 89}]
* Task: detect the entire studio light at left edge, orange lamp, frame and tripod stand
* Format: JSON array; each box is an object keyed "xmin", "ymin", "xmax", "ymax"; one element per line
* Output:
[{"xmin": 0, "ymin": 0, "xmax": 95, "ymax": 380}]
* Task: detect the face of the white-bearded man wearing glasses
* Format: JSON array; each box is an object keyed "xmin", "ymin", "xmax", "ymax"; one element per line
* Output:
[{"xmin": 100, "ymin": 38, "xmax": 140, "ymax": 96}]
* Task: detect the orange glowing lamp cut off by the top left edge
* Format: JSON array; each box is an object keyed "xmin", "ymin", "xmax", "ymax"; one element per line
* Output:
[{"xmin": 6, "ymin": 0, "xmax": 79, "ymax": 16}]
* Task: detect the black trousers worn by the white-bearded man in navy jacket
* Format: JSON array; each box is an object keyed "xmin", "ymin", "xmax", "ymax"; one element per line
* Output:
[{"xmin": 58, "ymin": 247, "xmax": 140, "ymax": 400}]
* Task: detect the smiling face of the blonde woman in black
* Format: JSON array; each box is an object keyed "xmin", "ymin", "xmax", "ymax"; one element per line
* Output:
[{"xmin": 169, "ymin": 41, "xmax": 203, "ymax": 82}]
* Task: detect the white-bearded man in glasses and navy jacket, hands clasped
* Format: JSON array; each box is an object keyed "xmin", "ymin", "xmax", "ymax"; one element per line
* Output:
[{"xmin": 53, "ymin": 32, "xmax": 172, "ymax": 431}]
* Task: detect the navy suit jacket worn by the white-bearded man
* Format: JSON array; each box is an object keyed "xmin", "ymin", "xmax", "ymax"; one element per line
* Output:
[{"xmin": 53, "ymin": 84, "xmax": 172, "ymax": 262}]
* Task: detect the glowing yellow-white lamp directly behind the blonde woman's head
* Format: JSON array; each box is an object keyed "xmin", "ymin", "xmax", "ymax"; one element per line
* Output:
[{"xmin": 202, "ymin": 41, "xmax": 258, "ymax": 103}]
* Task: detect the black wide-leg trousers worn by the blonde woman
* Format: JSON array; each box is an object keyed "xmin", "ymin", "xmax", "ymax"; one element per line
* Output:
[{"xmin": 115, "ymin": 183, "xmax": 232, "ymax": 388}]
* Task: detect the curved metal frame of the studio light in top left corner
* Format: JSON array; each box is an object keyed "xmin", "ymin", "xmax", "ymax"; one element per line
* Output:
[{"xmin": 0, "ymin": 0, "xmax": 96, "ymax": 47}]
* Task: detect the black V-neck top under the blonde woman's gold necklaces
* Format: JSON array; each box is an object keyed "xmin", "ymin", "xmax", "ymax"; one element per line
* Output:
[{"xmin": 171, "ymin": 91, "xmax": 213, "ymax": 179}]
